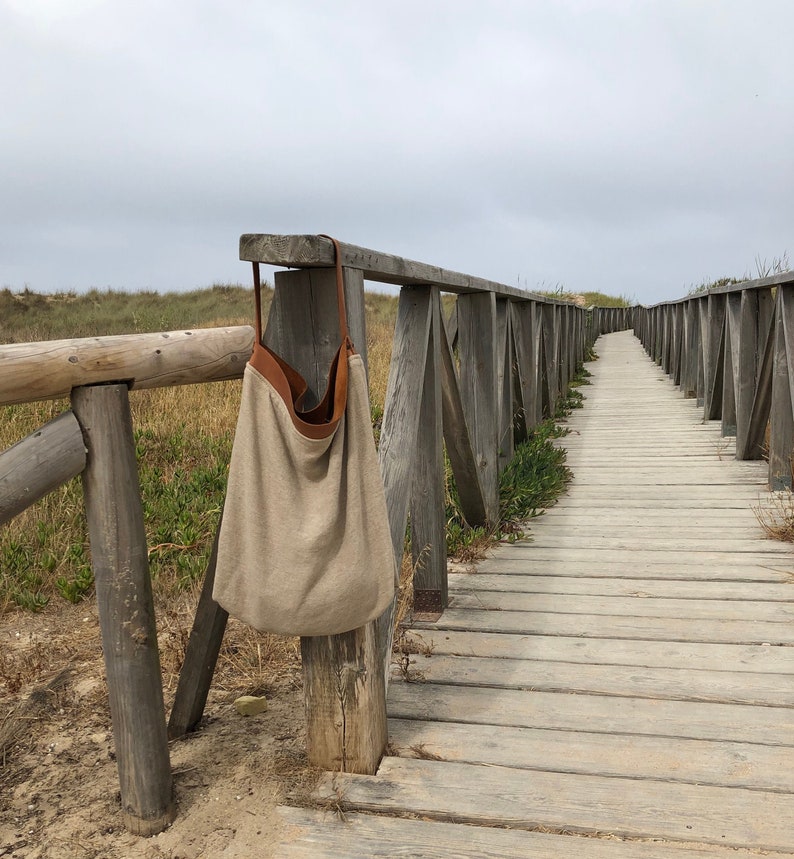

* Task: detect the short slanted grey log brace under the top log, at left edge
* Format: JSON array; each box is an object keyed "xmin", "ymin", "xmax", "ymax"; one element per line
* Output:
[{"xmin": 0, "ymin": 412, "xmax": 85, "ymax": 525}]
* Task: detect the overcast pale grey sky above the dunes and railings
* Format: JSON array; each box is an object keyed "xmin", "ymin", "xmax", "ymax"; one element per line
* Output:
[{"xmin": 0, "ymin": 0, "xmax": 794, "ymax": 303}]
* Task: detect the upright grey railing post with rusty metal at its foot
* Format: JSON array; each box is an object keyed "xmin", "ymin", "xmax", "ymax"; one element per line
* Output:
[{"xmin": 410, "ymin": 286, "xmax": 447, "ymax": 613}]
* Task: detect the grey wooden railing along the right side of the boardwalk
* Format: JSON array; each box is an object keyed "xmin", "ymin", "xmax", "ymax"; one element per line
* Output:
[{"xmin": 634, "ymin": 272, "xmax": 794, "ymax": 490}]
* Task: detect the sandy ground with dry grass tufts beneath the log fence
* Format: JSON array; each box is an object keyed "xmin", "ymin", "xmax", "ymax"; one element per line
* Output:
[{"xmin": 0, "ymin": 600, "xmax": 317, "ymax": 859}]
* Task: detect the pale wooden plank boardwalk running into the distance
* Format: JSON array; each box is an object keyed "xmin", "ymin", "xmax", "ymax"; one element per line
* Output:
[{"xmin": 277, "ymin": 332, "xmax": 794, "ymax": 859}]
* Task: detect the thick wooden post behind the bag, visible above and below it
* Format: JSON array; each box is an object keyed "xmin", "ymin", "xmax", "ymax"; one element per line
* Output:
[{"xmin": 264, "ymin": 268, "xmax": 387, "ymax": 774}]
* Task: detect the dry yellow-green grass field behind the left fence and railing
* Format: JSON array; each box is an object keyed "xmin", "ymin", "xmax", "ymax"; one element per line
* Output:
[{"xmin": 0, "ymin": 285, "xmax": 580, "ymax": 611}]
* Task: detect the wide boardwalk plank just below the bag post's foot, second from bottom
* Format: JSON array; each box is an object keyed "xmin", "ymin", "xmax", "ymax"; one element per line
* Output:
[{"xmin": 319, "ymin": 758, "xmax": 794, "ymax": 851}]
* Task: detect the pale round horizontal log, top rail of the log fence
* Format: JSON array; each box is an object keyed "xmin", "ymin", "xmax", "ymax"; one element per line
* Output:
[{"xmin": 0, "ymin": 325, "xmax": 254, "ymax": 406}]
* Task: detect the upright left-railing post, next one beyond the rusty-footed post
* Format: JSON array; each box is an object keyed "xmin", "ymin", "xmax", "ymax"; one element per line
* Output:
[{"xmin": 458, "ymin": 292, "xmax": 499, "ymax": 522}]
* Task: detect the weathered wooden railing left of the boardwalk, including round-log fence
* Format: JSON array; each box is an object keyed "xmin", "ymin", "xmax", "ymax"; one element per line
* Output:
[{"xmin": 0, "ymin": 235, "xmax": 630, "ymax": 833}]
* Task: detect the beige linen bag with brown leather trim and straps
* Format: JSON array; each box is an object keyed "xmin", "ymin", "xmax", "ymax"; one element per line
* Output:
[{"xmin": 212, "ymin": 237, "xmax": 397, "ymax": 636}]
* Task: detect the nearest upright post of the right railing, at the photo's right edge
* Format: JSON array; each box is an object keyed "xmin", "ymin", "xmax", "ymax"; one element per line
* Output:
[{"xmin": 769, "ymin": 286, "xmax": 794, "ymax": 492}]
